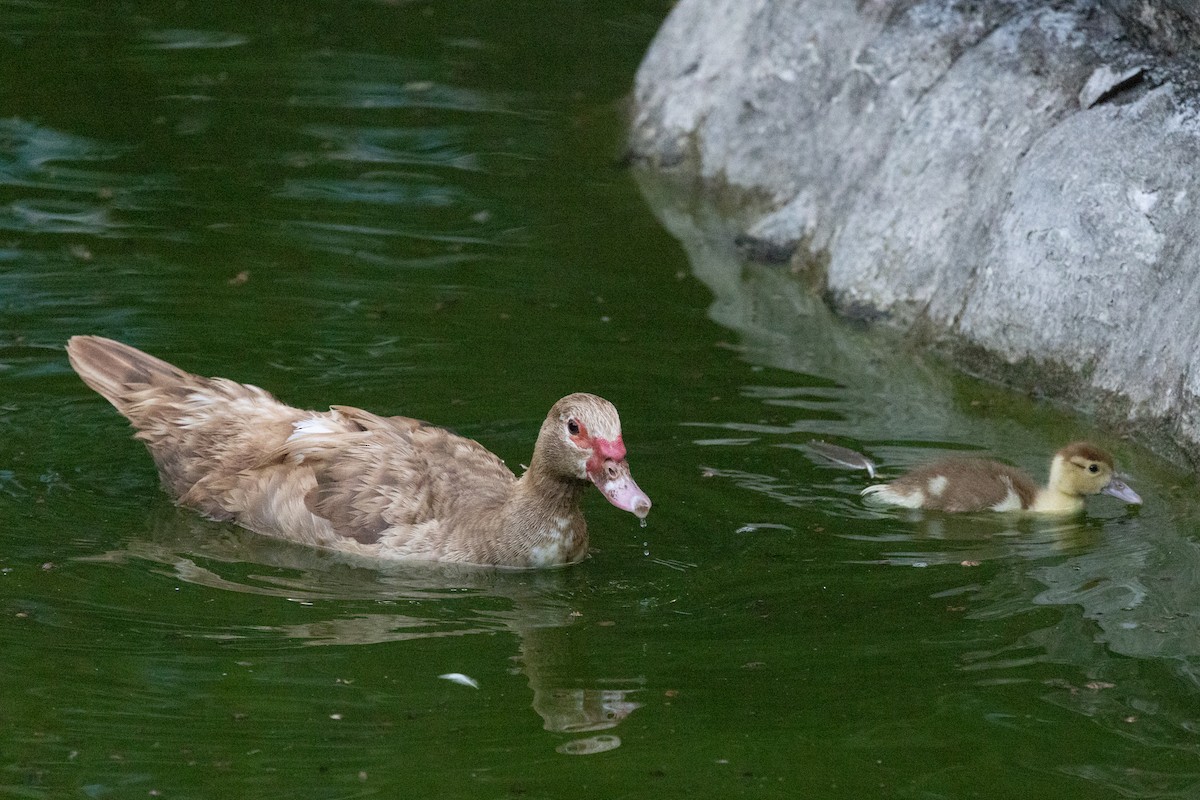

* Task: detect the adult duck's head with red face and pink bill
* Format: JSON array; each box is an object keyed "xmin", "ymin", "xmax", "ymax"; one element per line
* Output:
[{"xmin": 530, "ymin": 392, "xmax": 650, "ymax": 519}]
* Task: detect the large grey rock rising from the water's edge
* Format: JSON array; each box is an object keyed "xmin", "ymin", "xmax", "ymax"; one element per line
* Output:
[{"xmin": 630, "ymin": 0, "xmax": 1200, "ymax": 463}]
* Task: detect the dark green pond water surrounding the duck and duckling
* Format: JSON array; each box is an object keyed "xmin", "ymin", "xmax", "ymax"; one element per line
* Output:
[{"xmin": 0, "ymin": 0, "xmax": 1200, "ymax": 800}]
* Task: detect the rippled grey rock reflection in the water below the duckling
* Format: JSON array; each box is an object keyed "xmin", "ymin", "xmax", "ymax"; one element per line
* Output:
[{"xmin": 947, "ymin": 506, "xmax": 1200, "ymax": 762}]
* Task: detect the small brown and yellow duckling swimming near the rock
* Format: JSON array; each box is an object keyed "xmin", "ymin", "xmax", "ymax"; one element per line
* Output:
[{"xmin": 862, "ymin": 441, "xmax": 1141, "ymax": 515}]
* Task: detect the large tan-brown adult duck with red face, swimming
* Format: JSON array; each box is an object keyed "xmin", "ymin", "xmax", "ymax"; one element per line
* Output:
[{"xmin": 66, "ymin": 336, "xmax": 650, "ymax": 569}]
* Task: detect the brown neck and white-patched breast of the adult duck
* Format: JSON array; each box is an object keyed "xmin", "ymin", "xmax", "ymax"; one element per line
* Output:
[{"xmin": 504, "ymin": 464, "xmax": 588, "ymax": 567}]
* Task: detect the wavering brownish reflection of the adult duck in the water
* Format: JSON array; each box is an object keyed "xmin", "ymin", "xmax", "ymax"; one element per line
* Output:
[{"xmin": 86, "ymin": 509, "xmax": 642, "ymax": 738}]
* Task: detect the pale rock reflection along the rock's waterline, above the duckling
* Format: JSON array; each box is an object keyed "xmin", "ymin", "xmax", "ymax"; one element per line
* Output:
[{"xmin": 634, "ymin": 172, "xmax": 1080, "ymax": 460}]
